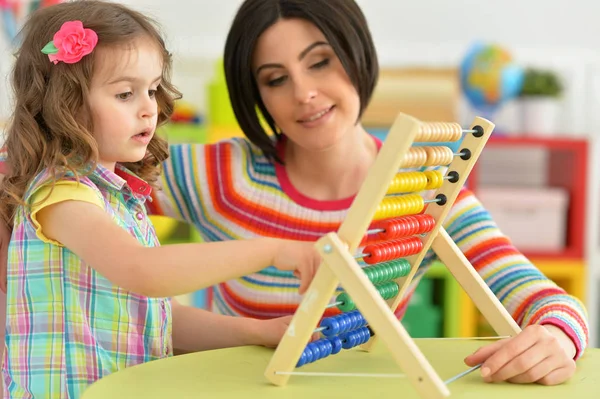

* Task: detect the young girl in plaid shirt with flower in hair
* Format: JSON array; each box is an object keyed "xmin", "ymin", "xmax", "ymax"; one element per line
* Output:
[{"xmin": 0, "ymin": 1, "xmax": 319, "ymax": 399}]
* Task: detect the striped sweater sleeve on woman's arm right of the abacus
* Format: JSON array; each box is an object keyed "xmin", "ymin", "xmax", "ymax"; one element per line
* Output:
[{"xmin": 445, "ymin": 189, "xmax": 589, "ymax": 359}]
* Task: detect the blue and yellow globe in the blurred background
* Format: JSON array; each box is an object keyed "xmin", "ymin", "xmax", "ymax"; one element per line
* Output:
[{"xmin": 460, "ymin": 43, "xmax": 524, "ymax": 111}]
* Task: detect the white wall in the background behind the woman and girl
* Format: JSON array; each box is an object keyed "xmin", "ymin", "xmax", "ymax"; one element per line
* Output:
[{"xmin": 0, "ymin": 0, "xmax": 600, "ymax": 133}]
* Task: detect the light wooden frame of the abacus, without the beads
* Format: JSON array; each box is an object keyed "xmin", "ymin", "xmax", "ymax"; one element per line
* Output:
[{"xmin": 265, "ymin": 113, "xmax": 520, "ymax": 399}]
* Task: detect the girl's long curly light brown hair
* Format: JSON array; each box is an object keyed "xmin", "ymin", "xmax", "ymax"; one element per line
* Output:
[{"xmin": 0, "ymin": 0, "xmax": 181, "ymax": 226}]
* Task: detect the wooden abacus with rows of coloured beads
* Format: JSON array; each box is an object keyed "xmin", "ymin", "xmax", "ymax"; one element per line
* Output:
[{"xmin": 265, "ymin": 114, "xmax": 521, "ymax": 399}]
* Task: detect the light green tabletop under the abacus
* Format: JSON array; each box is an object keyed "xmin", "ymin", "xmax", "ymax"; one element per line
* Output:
[{"xmin": 82, "ymin": 339, "xmax": 600, "ymax": 399}]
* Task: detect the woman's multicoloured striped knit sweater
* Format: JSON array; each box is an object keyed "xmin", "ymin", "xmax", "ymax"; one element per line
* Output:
[{"xmin": 151, "ymin": 138, "xmax": 588, "ymax": 357}]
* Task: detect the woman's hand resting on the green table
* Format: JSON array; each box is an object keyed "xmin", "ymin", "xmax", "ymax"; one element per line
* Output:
[{"xmin": 465, "ymin": 325, "xmax": 576, "ymax": 385}]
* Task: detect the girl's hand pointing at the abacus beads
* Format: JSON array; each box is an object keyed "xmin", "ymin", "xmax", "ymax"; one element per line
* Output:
[{"xmin": 273, "ymin": 240, "xmax": 321, "ymax": 294}]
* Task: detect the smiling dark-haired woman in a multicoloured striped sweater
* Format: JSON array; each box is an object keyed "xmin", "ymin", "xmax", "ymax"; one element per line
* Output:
[{"xmin": 0, "ymin": 0, "xmax": 588, "ymax": 390}]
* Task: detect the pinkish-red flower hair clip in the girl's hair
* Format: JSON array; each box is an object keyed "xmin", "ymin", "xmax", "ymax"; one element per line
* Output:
[{"xmin": 42, "ymin": 21, "xmax": 98, "ymax": 64}]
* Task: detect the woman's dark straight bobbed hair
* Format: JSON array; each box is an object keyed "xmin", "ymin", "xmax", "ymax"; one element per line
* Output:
[{"xmin": 224, "ymin": 0, "xmax": 379, "ymax": 161}]
